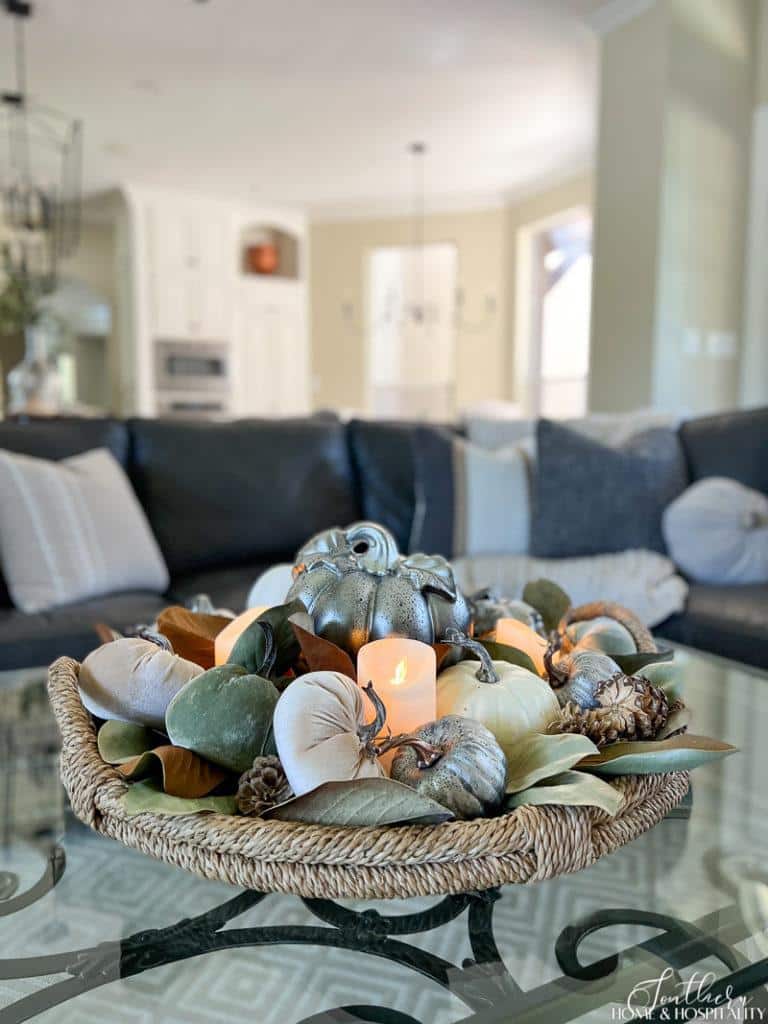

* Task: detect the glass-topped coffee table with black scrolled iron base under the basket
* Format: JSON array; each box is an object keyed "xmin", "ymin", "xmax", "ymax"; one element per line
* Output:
[{"xmin": 0, "ymin": 649, "xmax": 768, "ymax": 1024}]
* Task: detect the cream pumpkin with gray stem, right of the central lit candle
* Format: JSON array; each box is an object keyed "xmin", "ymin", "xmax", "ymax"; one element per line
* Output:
[{"xmin": 437, "ymin": 659, "xmax": 560, "ymax": 754}]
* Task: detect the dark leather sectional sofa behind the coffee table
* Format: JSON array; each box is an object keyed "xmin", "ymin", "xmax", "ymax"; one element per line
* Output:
[{"xmin": 0, "ymin": 410, "xmax": 768, "ymax": 671}]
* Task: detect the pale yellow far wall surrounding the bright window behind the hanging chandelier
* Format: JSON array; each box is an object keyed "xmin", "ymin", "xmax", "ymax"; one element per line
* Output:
[{"xmin": 309, "ymin": 175, "xmax": 592, "ymax": 410}]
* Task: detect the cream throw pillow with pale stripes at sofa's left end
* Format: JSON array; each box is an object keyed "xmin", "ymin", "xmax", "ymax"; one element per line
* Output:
[{"xmin": 0, "ymin": 449, "xmax": 168, "ymax": 612}]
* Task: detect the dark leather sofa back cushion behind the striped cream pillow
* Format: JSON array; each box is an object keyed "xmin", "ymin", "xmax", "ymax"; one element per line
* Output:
[{"xmin": 0, "ymin": 417, "xmax": 130, "ymax": 608}]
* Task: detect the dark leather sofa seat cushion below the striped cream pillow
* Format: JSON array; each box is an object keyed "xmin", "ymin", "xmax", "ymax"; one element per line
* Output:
[{"xmin": 0, "ymin": 592, "xmax": 168, "ymax": 671}]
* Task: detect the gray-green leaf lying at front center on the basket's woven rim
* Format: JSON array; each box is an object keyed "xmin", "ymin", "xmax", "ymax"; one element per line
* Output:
[{"xmin": 264, "ymin": 778, "xmax": 454, "ymax": 827}]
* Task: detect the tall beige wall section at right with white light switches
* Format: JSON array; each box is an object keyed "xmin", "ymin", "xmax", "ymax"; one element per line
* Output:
[{"xmin": 590, "ymin": 0, "xmax": 757, "ymax": 415}]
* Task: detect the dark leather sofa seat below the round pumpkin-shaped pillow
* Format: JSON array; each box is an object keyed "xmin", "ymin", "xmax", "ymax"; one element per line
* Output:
[{"xmin": 656, "ymin": 584, "xmax": 768, "ymax": 669}]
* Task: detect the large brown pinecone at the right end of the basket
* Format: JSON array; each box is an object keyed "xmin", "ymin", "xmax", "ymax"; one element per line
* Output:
[{"xmin": 552, "ymin": 672, "xmax": 670, "ymax": 746}]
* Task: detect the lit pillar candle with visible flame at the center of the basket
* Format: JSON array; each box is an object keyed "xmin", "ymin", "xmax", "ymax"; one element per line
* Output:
[{"xmin": 357, "ymin": 637, "xmax": 437, "ymax": 749}]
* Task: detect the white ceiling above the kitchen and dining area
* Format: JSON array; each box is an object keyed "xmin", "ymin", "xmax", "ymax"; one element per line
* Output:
[{"xmin": 7, "ymin": 0, "xmax": 601, "ymax": 214}]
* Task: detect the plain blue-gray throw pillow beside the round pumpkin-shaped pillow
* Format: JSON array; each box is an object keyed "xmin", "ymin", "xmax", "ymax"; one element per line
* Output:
[{"xmin": 530, "ymin": 420, "xmax": 688, "ymax": 558}]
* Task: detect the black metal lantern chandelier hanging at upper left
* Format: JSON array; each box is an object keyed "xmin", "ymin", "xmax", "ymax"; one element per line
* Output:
[{"xmin": 0, "ymin": 0, "xmax": 82, "ymax": 290}]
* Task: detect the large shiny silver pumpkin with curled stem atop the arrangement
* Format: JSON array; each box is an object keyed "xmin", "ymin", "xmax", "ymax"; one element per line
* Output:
[{"xmin": 288, "ymin": 522, "xmax": 470, "ymax": 654}]
